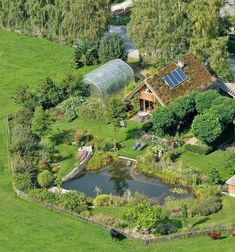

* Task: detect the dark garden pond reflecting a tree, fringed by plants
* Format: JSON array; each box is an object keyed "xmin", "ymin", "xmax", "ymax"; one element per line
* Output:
[{"xmin": 61, "ymin": 165, "xmax": 190, "ymax": 202}]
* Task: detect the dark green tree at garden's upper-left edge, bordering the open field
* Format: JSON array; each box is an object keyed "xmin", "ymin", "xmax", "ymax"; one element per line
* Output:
[{"xmin": 37, "ymin": 78, "xmax": 64, "ymax": 110}]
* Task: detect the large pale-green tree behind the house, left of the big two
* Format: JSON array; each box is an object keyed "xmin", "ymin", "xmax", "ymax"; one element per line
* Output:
[{"xmin": 128, "ymin": 0, "xmax": 190, "ymax": 64}]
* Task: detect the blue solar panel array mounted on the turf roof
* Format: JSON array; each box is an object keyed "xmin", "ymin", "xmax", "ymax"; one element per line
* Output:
[{"xmin": 163, "ymin": 67, "xmax": 187, "ymax": 89}]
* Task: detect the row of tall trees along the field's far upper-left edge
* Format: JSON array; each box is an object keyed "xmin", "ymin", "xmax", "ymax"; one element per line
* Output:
[{"xmin": 0, "ymin": 0, "xmax": 111, "ymax": 41}]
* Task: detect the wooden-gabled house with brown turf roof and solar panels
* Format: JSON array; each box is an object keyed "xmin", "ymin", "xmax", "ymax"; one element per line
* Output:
[{"xmin": 126, "ymin": 52, "xmax": 216, "ymax": 112}]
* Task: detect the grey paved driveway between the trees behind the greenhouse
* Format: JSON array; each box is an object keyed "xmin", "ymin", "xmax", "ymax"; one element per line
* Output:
[{"xmin": 109, "ymin": 25, "xmax": 139, "ymax": 59}]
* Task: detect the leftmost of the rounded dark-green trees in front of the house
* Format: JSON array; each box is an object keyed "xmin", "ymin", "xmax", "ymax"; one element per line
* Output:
[{"xmin": 152, "ymin": 107, "xmax": 177, "ymax": 136}]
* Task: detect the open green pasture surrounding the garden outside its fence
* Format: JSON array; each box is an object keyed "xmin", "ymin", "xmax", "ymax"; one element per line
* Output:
[{"xmin": 0, "ymin": 30, "xmax": 235, "ymax": 252}]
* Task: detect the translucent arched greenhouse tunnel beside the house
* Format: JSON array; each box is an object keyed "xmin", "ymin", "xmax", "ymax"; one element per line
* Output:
[{"xmin": 84, "ymin": 59, "xmax": 134, "ymax": 95}]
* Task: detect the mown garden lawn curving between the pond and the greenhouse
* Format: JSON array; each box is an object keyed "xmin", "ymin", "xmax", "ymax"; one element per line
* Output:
[{"xmin": 50, "ymin": 118, "xmax": 144, "ymax": 177}]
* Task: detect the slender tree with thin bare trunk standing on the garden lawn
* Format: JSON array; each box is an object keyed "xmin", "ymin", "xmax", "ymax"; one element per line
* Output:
[{"xmin": 106, "ymin": 96, "xmax": 126, "ymax": 150}]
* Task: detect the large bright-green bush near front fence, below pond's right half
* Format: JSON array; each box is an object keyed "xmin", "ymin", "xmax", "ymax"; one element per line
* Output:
[{"xmin": 123, "ymin": 201, "xmax": 168, "ymax": 230}]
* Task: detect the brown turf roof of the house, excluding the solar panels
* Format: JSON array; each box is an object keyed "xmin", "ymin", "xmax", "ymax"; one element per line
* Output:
[{"xmin": 126, "ymin": 52, "xmax": 215, "ymax": 104}]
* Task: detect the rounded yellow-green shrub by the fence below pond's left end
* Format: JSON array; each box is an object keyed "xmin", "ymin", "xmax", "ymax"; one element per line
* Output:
[{"xmin": 57, "ymin": 191, "xmax": 88, "ymax": 213}]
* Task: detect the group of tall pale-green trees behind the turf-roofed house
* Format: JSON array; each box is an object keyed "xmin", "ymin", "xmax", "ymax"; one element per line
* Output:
[{"xmin": 128, "ymin": 0, "xmax": 232, "ymax": 80}]
